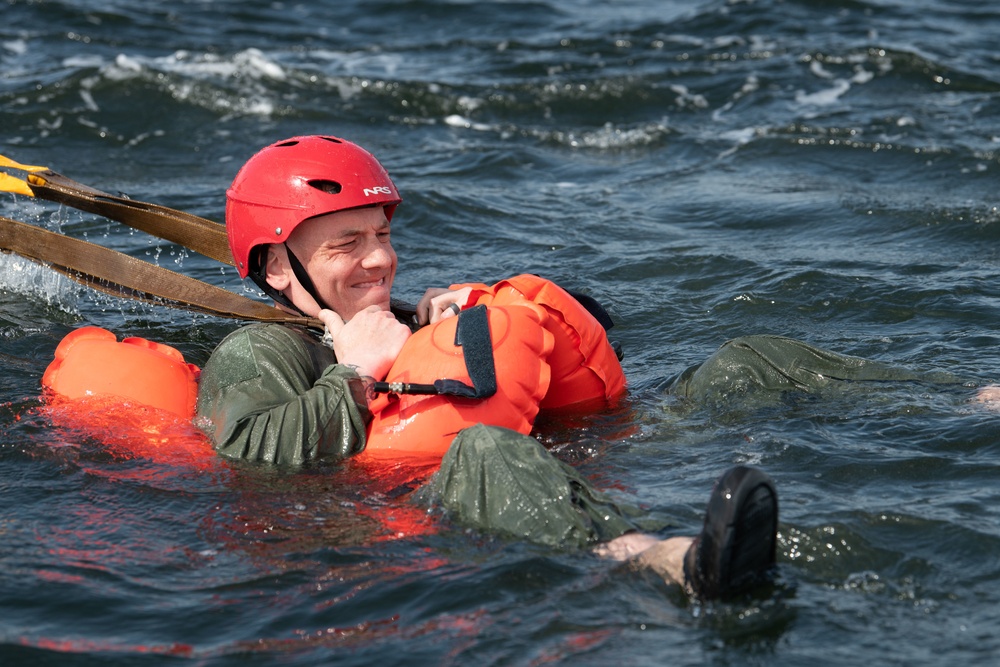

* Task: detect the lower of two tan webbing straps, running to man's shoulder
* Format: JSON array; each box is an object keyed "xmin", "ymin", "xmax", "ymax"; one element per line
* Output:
[{"xmin": 0, "ymin": 216, "xmax": 323, "ymax": 329}]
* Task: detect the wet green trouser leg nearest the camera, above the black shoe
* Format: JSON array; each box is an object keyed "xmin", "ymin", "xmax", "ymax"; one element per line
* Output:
[{"xmin": 421, "ymin": 424, "xmax": 636, "ymax": 548}]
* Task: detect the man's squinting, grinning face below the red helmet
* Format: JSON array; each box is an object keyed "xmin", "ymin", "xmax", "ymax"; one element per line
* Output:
[{"xmin": 267, "ymin": 206, "xmax": 397, "ymax": 321}]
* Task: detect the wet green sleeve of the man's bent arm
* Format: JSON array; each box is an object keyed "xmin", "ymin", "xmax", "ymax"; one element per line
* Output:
[{"xmin": 198, "ymin": 324, "xmax": 371, "ymax": 465}]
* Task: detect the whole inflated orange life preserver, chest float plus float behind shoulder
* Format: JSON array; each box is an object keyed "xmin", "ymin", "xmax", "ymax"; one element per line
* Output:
[{"xmin": 42, "ymin": 275, "xmax": 625, "ymax": 470}]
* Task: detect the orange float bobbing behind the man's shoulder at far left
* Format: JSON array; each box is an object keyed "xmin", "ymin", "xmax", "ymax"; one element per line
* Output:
[{"xmin": 42, "ymin": 327, "xmax": 214, "ymax": 466}]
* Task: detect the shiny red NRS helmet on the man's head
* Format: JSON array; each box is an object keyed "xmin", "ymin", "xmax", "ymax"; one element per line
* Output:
[{"xmin": 226, "ymin": 136, "xmax": 402, "ymax": 278}]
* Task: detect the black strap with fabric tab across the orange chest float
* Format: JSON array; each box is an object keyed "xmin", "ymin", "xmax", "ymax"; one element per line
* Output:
[{"xmin": 372, "ymin": 306, "xmax": 497, "ymax": 399}]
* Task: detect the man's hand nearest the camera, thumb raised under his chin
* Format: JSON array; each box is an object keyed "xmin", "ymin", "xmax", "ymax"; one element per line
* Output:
[{"xmin": 319, "ymin": 306, "xmax": 410, "ymax": 380}]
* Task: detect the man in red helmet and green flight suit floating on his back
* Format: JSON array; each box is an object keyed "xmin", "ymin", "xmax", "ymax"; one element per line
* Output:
[{"xmin": 198, "ymin": 136, "xmax": 778, "ymax": 598}]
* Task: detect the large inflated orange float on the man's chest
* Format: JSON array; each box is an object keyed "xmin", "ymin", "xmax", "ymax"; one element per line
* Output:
[{"xmin": 365, "ymin": 275, "xmax": 625, "ymax": 459}]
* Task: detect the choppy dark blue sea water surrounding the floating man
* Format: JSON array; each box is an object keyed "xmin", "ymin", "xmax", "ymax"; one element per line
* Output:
[{"xmin": 0, "ymin": 0, "xmax": 1000, "ymax": 665}]
